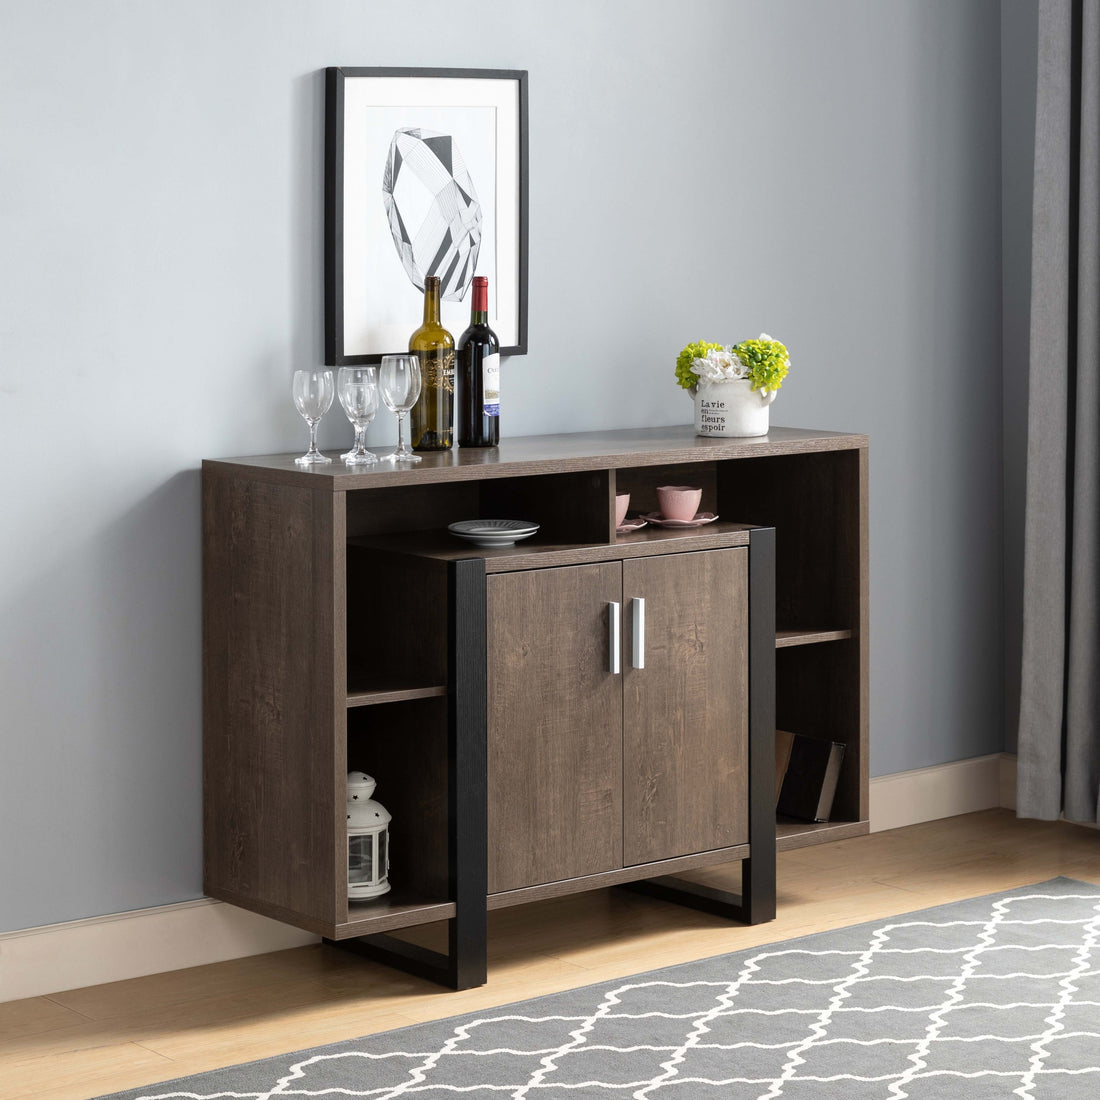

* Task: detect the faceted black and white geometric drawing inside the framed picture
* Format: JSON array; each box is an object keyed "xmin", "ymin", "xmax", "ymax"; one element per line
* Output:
[{"xmin": 382, "ymin": 127, "xmax": 482, "ymax": 301}]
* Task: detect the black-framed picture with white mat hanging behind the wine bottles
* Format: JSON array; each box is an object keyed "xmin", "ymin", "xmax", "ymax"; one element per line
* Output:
[{"xmin": 325, "ymin": 68, "xmax": 527, "ymax": 366}]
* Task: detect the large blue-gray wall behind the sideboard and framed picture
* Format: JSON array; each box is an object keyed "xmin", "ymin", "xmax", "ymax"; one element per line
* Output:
[{"xmin": 0, "ymin": 0, "xmax": 1003, "ymax": 928}]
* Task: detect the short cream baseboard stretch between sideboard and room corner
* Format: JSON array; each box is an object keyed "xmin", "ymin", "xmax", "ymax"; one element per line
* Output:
[{"xmin": 871, "ymin": 752, "xmax": 1015, "ymax": 833}]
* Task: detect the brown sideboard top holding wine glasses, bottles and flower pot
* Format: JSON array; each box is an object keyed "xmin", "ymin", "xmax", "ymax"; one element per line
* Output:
[{"xmin": 202, "ymin": 425, "xmax": 867, "ymax": 493}]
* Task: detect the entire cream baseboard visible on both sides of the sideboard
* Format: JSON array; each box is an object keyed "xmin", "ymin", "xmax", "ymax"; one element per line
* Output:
[{"xmin": 0, "ymin": 754, "xmax": 1016, "ymax": 1001}]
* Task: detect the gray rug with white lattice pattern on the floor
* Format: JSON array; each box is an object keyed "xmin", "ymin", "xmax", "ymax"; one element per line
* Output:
[{"xmin": 105, "ymin": 878, "xmax": 1100, "ymax": 1100}]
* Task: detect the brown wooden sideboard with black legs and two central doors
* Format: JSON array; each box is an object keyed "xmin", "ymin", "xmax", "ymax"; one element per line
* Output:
[{"xmin": 202, "ymin": 428, "xmax": 868, "ymax": 988}]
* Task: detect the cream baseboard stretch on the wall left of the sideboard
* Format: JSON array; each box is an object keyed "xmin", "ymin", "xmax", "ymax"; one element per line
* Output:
[{"xmin": 0, "ymin": 898, "xmax": 318, "ymax": 1001}]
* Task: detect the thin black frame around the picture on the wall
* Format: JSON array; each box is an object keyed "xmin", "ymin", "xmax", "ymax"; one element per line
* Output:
[{"xmin": 325, "ymin": 66, "xmax": 528, "ymax": 366}]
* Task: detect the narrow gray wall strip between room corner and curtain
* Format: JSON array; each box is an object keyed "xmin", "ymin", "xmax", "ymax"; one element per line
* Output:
[{"xmin": 1001, "ymin": 0, "xmax": 1038, "ymax": 752}]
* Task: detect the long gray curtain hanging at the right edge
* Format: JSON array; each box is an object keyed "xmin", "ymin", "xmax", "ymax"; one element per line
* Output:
[{"xmin": 1016, "ymin": 0, "xmax": 1100, "ymax": 822}]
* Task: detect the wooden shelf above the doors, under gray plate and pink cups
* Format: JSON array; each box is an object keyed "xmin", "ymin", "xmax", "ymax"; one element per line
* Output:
[{"xmin": 348, "ymin": 520, "xmax": 750, "ymax": 573}]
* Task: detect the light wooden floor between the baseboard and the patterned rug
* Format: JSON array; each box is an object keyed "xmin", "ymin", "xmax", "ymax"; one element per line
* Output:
[{"xmin": 0, "ymin": 810, "xmax": 1100, "ymax": 1100}]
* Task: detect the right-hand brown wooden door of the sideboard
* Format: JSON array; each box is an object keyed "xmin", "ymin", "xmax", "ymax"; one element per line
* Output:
[{"xmin": 623, "ymin": 548, "xmax": 748, "ymax": 866}]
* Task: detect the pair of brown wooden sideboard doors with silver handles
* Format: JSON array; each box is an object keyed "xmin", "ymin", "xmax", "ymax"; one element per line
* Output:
[{"xmin": 486, "ymin": 548, "xmax": 748, "ymax": 894}]
